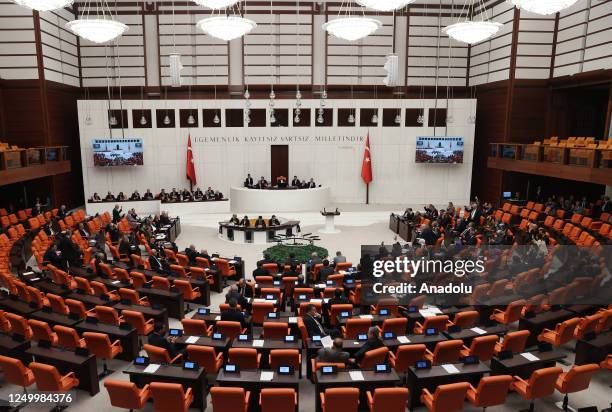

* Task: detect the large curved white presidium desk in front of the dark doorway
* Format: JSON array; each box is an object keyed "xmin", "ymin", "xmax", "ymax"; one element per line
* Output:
[{"xmin": 230, "ymin": 186, "xmax": 331, "ymax": 212}]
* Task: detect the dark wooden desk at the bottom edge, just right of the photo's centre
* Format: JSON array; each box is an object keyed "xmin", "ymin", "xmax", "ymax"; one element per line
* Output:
[{"xmin": 315, "ymin": 370, "xmax": 401, "ymax": 412}]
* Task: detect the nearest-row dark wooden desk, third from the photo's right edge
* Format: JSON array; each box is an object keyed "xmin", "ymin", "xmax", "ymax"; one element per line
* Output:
[{"xmin": 406, "ymin": 362, "xmax": 491, "ymax": 411}]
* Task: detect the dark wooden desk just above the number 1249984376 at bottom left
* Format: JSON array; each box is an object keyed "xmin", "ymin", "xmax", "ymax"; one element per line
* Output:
[{"xmin": 26, "ymin": 346, "xmax": 100, "ymax": 396}]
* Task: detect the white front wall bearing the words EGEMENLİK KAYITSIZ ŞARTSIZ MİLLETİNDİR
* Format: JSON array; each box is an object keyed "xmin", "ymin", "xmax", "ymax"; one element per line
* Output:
[{"xmin": 79, "ymin": 99, "xmax": 475, "ymax": 208}]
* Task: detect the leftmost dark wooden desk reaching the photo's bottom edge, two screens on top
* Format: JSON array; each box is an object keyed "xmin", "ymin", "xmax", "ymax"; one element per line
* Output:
[{"xmin": 123, "ymin": 365, "xmax": 208, "ymax": 412}]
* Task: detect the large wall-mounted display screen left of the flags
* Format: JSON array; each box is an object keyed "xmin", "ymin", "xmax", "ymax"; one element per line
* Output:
[{"xmin": 93, "ymin": 139, "xmax": 143, "ymax": 166}]
